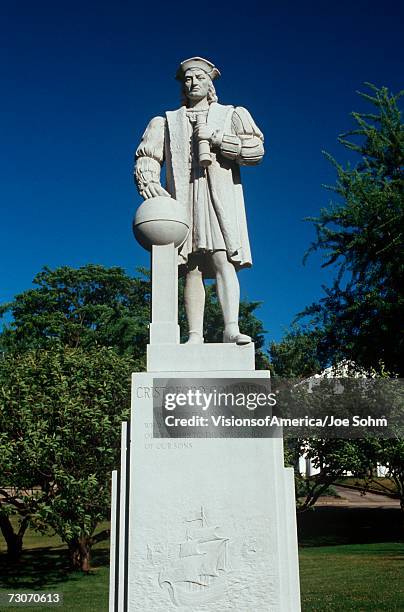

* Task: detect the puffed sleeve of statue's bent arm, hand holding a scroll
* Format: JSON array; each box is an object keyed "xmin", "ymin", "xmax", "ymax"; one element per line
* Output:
[{"xmin": 220, "ymin": 106, "xmax": 264, "ymax": 166}]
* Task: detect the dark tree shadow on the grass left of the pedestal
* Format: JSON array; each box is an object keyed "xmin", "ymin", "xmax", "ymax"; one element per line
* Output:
[{"xmin": 0, "ymin": 545, "xmax": 109, "ymax": 589}]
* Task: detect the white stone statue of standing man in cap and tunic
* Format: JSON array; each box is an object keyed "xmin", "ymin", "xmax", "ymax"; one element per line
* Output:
[{"xmin": 135, "ymin": 57, "xmax": 264, "ymax": 344}]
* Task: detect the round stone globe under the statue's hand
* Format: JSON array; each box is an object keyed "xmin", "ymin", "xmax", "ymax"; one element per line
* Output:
[{"xmin": 133, "ymin": 196, "xmax": 189, "ymax": 251}]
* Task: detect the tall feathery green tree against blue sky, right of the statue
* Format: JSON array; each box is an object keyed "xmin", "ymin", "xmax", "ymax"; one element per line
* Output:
[{"xmin": 300, "ymin": 84, "xmax": 404, "ymax": 372}]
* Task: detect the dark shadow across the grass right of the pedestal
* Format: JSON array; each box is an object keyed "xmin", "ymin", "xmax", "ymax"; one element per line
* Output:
[{"xmin": 297, "ymin": 507, "xmax": 403, "ymax": 554}]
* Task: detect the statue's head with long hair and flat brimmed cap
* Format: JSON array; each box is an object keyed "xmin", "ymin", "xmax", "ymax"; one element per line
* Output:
[{"xmin": 176, "ymin": 57, "xmax": 220, "ymax": 106}]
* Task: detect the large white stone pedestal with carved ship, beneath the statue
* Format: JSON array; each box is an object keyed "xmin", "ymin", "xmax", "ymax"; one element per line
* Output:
[{"xmin": 110, "ymin": 366, "xmax": 300, "ymax": 612}]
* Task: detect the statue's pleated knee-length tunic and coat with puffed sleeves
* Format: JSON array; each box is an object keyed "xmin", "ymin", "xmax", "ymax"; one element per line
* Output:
[{"xmin": 135, "ymin": 102, "xmax": 264, "ymax": 277}]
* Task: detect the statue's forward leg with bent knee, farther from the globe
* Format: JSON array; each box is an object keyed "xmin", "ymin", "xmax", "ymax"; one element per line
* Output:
[{"xmin": 212, "ymin": 251, "xmax": 251, "ymax": 344}]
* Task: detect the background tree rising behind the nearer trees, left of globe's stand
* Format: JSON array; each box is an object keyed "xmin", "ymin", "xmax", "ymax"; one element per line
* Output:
[{"xmin": 0, "ymin": 264, "xmax": 150, "ymax": 359}]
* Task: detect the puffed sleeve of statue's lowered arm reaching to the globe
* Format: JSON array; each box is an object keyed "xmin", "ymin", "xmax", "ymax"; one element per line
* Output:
[{"xmin": 134, "ymin": 117, "xmax": 166, "ymax": 194}]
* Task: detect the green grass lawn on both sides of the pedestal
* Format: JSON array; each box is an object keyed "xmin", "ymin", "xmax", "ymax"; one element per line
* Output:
[{"xmin": 0, "ymin": 525, "xmax": 404, "ymax": 612}]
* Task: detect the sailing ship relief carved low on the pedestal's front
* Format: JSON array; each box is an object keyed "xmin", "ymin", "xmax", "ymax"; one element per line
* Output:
[{"xmin": 159, "ymin": 507, "xmax": 230, "ymax": 606}]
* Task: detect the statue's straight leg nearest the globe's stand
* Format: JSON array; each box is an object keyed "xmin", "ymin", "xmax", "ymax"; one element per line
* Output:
[{"xmin": 184, "ymin": 262, "xmax": 205, "ymax": 344}]
